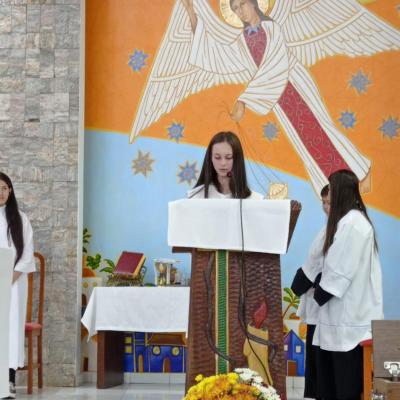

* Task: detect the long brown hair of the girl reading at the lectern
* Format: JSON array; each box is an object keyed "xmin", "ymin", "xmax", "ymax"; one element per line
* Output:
[{"xmin": 194, "ymin": 132, "xmax": 251, "ymax": 199}]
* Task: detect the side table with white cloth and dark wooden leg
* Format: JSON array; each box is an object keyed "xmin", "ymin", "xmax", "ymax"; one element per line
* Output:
[{"xmin": 81, "ymin": 286, "xmax": 190, "ymax": 389}]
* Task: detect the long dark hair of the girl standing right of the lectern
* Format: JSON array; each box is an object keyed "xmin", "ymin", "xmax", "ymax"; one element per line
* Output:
[{"xmin": 323, "ymin": 170, "xmax": 378, "ymax": 255}]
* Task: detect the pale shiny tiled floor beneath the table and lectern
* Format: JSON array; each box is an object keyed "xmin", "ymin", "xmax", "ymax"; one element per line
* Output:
[{"xmin": 17, "ymin": 383, "xmax": 303, "ymax": 400}]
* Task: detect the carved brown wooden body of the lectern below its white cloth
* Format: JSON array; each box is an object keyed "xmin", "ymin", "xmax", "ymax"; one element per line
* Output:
[{"xmin": 173, "ymin": 202, "xmax": 301, "ymax": 399}]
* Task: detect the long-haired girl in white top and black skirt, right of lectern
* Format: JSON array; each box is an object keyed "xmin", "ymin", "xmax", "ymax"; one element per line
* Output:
[{"xmin": 313, "ymin": 170, "xmax": 383, "ymax": 400}]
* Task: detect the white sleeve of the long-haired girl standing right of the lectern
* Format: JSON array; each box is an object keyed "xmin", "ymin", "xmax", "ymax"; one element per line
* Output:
[{"xmin": 320, "ymin": 224, "xmax": 369, "ymax": 298}]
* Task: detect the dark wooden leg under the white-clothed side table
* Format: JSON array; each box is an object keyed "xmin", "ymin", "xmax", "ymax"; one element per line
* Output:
[{"xmin": 97, "ymin": 331, "xmax": 125, "ymax": 389}]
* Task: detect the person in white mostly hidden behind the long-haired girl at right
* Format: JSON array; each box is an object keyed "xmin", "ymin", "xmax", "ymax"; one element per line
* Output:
[{"xmin": 291, "ymin": 185, "xmax": 330, "ymax": 399}]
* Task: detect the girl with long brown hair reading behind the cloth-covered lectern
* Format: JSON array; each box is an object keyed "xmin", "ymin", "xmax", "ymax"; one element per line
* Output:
[{"xmin": 188, "ymin": 132, "xmax": 263, "ymax": 200}]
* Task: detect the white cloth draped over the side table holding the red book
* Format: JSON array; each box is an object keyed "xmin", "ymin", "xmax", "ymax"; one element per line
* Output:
[{"xmin": 81, "ymin": 286, "xmax": 190, "ymax": 338}]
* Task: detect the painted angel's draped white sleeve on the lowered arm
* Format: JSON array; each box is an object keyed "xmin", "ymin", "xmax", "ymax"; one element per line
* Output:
[{"xmin": 239, "ymin": 23, "xmax": 289, "ymax": 115}]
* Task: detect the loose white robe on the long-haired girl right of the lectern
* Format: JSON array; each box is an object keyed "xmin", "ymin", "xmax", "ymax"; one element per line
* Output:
[{"xmin": 313, "ymin": 210, "xmax": 383, "ymax": 351}]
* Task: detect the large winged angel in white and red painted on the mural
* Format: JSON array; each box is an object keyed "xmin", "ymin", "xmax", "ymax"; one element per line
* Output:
[{"xmin": 131, "ymin": 0, "xmax": 400, "ymax": 193}]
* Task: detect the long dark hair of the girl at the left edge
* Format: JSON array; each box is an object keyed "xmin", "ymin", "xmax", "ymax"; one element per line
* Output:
[{"xmin": 0, "ymin": 172, "xmax": 24, "ymax": 265}]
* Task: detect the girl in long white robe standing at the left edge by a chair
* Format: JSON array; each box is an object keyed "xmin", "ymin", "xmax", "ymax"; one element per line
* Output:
[{"xmin": 0, "ymin": 172, "xmax": 35, "ymax": 398}]
